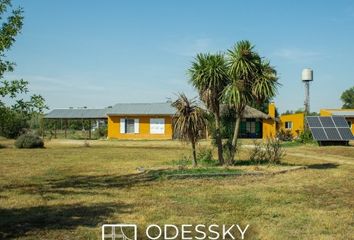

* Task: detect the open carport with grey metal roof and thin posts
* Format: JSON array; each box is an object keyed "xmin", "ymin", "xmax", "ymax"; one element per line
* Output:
[{"xmin": 42, "ymin": 108, "xmax": 109, "ymax": 139}]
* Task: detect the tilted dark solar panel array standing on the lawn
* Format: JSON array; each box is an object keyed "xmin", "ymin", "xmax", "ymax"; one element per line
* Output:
[{"xmin": 306, "ymin": 116, "xmax": 354, "ymax": 142}]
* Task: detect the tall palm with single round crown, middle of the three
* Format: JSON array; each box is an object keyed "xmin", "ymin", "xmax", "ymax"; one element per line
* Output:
[{"xmin": 189, "ymin": 54, "xmax": 228, "ymax": 165}]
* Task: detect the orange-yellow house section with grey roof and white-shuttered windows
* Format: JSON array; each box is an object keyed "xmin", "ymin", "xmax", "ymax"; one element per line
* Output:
[{"xmin": 107, "ymin": 103, "xmax": 175, "ymax": 139}]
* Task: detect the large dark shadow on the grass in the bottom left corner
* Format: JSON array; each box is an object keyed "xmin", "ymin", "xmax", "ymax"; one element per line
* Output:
[{"xmin": 0, "ymin": 203, "xmax": 129, "ymax": 239}]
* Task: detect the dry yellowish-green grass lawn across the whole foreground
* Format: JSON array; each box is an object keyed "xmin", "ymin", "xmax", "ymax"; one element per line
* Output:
[{"xmin": 0, "ymin": 140, "xmax": 354, "ymax": 239}]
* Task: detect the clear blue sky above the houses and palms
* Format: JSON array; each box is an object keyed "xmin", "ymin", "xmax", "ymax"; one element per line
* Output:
[{"xmin": 7, "ymin": 0, "xmax": 354, "ymax": 112}]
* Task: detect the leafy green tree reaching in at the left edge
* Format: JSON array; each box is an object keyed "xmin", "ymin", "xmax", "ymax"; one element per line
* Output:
[{"xmin": 0, "ymin": 0, "xmax": 46, "ymax": 137}]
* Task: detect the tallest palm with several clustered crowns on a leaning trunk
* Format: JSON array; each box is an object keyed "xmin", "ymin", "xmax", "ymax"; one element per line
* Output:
[{"xmin": 223, "ymin": 41, "xmax": 279, "ymax": 162}]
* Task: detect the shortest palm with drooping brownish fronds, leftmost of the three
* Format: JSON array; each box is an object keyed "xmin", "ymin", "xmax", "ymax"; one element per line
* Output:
[{"xmin": 172, "ymin": 93, "xmax": 206, "ymax": 167}]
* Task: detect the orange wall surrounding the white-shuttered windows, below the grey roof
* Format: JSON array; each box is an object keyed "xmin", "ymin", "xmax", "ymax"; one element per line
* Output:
[{"xmin": 108, "ymin": 115, "xmax": 172, "ymax": 139}]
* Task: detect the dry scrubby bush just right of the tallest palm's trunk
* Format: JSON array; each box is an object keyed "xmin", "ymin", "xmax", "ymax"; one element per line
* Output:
[{"xmin": 249, "ymin": 138, "xmax": 285, "ymax": 164}]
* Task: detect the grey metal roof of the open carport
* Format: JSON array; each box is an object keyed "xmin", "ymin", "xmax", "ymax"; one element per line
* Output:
[{"xmin": 44, "ymin": 109, "xmax": 108, "ymax": 119}]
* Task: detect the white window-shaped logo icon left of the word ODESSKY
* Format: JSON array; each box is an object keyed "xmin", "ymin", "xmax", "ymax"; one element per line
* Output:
[{"xmin": 102, "ymin": 224, "xmax": 138, "ymax": 240}]
